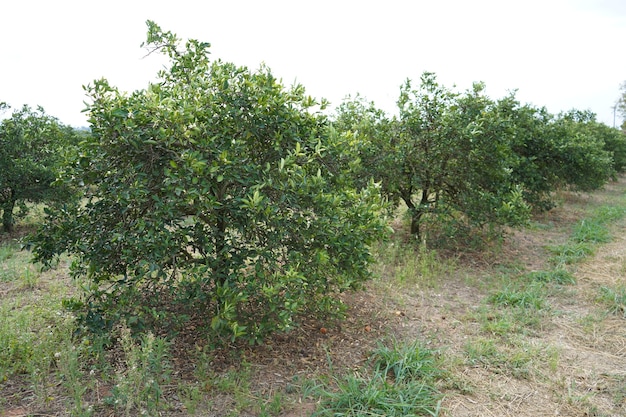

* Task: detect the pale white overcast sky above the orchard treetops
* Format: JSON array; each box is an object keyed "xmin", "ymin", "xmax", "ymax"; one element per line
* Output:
[{"xmin": 0, "ymin": 0, "xmax": 626, "ymax": 126}]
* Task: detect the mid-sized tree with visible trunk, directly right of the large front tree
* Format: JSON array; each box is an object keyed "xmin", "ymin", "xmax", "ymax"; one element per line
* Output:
[{"xmin": 335, "ymin": 73, "xmax": 529, "ymax": 240}]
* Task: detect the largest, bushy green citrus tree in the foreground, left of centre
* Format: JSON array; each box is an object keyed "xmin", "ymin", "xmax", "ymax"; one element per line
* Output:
[{"xmin": 33, "ymin": 22, "xmax": 386, "ymax": 341}]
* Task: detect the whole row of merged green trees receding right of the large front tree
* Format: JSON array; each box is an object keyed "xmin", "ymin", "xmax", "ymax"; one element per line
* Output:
[{"xmin": 334, "ymin": 73, "xmax": 626, "ymax": 240}]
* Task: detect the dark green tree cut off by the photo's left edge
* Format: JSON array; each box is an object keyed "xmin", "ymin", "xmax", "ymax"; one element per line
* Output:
[{"xmin": 0, "ymin": 104, "xmax": 79, "ymax": 232}]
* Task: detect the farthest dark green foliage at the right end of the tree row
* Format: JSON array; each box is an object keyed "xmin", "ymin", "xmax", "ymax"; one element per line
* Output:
[{"xmin": 510, "ymin": 103, "xmax": 625, "ymax": 210}]
